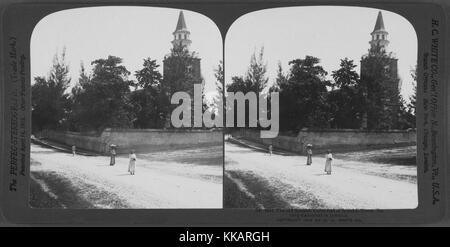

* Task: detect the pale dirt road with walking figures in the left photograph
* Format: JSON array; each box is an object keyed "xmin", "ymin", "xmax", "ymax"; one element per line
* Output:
[{"xmin": 30, "ymin": 144, "xmax": 222, "ymax": 208}]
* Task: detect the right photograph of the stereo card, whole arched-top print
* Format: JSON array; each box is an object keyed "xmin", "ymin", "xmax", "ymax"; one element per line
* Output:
[{"xmin": 223, "ymin": 6, "xmax": 418, "ymax": 209}]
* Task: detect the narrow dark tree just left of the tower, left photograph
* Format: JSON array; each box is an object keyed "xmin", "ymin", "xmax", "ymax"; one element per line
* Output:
[{"xmin": 130, "ymin": 58, "xmax": 169, "ymax": 128}]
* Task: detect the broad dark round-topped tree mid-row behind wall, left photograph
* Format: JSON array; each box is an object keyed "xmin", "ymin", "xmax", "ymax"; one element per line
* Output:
[{"xmin": 73, "ymin": 56, "xmax": 134, "ymax": 131}]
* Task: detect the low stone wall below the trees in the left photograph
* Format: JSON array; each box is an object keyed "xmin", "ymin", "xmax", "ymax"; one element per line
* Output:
[{"xmin": 41, "ymin": 129, "xmax": 223, "ymax": 153}]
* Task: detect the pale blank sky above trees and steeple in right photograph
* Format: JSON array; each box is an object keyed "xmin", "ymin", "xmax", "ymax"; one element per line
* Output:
[{"xmin": 225, "ymin": 6, "xmax": 417, "ymax": 100}]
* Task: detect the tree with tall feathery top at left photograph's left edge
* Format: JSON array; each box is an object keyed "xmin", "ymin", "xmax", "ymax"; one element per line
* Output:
[{"xmin": 31, "ymin": 49, "xmax": 70, "ymax": 132}]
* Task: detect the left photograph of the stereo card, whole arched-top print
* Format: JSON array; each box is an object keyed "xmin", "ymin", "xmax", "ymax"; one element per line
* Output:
[{"xmin": 29, "ymin": 7, "xmax": 223, "ymax": 209}]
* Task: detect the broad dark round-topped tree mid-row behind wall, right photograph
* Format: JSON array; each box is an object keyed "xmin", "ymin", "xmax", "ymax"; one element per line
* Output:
[{"xmin": 279, "ymin": 56, "xmax": 331, "ymax": 131}]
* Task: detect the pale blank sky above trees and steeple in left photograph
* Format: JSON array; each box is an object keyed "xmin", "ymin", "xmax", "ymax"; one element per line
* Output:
[{"xmin": 31, "ymin": 7, "xmax": 223, "ymax": 101}]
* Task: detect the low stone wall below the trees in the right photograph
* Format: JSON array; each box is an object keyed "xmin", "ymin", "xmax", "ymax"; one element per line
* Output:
[{"xmin": 232, "ymin": 129, "xmax": 416, "ymax": 153}]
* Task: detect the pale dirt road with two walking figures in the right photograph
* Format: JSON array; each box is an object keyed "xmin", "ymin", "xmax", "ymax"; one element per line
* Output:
[{"xmin": 224, "ymin": 142, "xmax": 417, "ymax": 209}]
